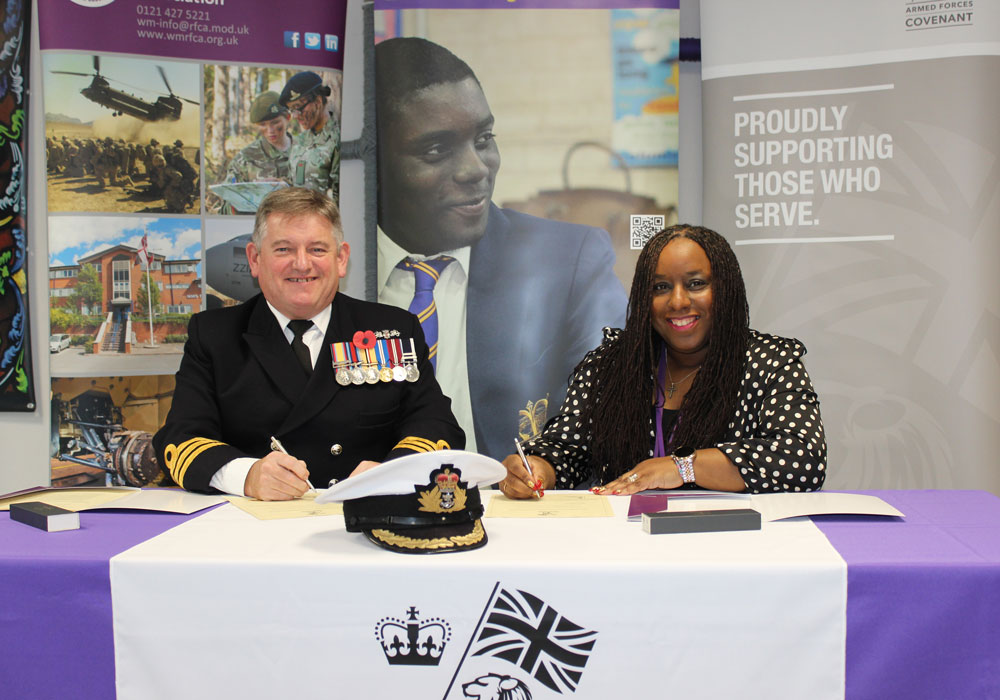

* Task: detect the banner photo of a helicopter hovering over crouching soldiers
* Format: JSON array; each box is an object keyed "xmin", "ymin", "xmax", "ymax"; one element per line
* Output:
[{"xmin": 43, "ymin": 54, "xmax": 201, "ymax": 214}]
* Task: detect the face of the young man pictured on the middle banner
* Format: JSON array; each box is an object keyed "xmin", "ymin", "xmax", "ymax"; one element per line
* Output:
[{"xmin": 379, "ymin": 78, "xmax": 500, "ymax": 255}]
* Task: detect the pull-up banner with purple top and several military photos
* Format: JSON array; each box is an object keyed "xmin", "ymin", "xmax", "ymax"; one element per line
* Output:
[{"xmin": 33, "ymin": 0, "xmax": 348, "ymax": 486}]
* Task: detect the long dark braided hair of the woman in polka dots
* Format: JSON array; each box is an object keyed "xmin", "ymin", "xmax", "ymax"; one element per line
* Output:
[{"xmin": 583, "ymin": 224, "xmax": 750, "ymax": 483}]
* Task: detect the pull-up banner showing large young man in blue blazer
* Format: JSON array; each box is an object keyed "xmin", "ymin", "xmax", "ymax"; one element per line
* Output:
[{"xmin": 373, "ymin": 0, "xmax": 680, "ymax": 459}]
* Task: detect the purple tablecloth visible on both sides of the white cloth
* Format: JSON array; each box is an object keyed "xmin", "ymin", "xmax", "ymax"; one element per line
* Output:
[{"xmin": 0, "ymin": 491, "xmax": 1000, "ymax": 700}]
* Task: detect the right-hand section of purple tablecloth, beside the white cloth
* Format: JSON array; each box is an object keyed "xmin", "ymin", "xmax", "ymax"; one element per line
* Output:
[{"xmin": 813, "ymin": 491, "xmax": 1000, "ymax": 700}]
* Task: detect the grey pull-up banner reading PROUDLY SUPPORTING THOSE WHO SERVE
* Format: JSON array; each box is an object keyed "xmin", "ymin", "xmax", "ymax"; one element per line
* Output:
[{"xmin": 701, "ymin": 0, "xmax": 1000, "ymax": 491}]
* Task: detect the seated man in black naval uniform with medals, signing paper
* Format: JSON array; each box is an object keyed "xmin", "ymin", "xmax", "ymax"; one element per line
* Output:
[{"xmin": 153, "ymin": 187, "xmax": 465, "ymax": 500}]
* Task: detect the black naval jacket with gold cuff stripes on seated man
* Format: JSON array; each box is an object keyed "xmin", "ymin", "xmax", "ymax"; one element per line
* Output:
[{"xmin": 153, "ymin": 293, "xmax": 465, "ymax": 492}]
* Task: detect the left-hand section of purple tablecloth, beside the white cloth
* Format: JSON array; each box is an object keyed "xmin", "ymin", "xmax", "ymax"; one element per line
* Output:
[{"xmin": 0, "ymin": 511, "xmax": 205, "ymax": 700}]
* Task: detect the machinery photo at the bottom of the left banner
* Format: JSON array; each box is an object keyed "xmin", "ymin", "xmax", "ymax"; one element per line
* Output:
[{"xmin": 49, "ymin": 375, "xmax": 174, "ymax": 486}]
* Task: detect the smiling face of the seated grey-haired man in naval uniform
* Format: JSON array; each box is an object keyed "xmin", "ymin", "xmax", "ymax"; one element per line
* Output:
[{"xmin": 247, "ymin": 214, "xmax": 350, "ymax": 319}]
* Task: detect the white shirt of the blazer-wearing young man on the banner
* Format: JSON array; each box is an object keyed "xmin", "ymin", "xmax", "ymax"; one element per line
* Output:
[{"xmin": 378, "ymin": 229, "xmax": 476, "ymax": 452}]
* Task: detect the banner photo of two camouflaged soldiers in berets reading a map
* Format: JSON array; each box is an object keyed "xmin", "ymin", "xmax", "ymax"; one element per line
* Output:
[{"xmin": 204, "ymin": 65, "xmax": 343, "ymax": 214}]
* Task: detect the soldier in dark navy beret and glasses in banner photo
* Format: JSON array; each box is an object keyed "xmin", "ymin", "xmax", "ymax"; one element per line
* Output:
[{"xmin": 279, "ymin": 70, "xmax": 340, "ymax": 202}]
